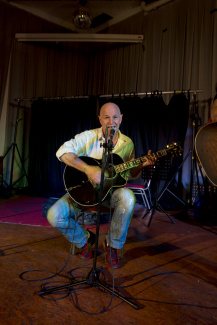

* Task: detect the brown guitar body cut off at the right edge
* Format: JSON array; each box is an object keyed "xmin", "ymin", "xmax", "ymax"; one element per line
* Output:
[{"xmin": 195, "ymin": 122, "xmax": 217, "ymax": 186}]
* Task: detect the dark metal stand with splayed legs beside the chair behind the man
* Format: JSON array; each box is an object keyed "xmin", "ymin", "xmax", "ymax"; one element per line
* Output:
[{"xmin": 142, "ymin": 150, "xmax": 191, "ymax": 227}]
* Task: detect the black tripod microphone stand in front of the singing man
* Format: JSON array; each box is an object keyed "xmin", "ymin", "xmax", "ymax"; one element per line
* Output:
[{"xmin": 39, "ymin": 127, "xmax": 139, "ymax": 309}]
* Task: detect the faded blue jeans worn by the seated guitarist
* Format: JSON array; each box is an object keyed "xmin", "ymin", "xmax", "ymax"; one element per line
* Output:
[{"xmin": 47, "ymin": 188, "xmax": 136, "ymax": 249}]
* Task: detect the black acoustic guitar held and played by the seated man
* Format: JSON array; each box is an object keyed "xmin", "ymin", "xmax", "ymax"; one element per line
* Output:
[{"xmin": 63, "ymin": 143, "xmax": 182, "ymax": 206}]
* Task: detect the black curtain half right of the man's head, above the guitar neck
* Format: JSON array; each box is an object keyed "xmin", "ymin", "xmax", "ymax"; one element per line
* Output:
[{"xmin": 99, "ymin": 94, "xmax": 189, "ymax": 157}]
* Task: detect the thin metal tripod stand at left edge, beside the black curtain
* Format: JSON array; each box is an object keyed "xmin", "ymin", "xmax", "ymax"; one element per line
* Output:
[{"xmin": 2, "ymin": 99, "xmax": 28, "ymax": 196}]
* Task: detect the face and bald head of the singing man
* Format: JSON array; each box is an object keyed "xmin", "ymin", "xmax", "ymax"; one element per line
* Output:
[{"xmin": 99, "ymin": 103, "xmax": 122, "ymax": 136}]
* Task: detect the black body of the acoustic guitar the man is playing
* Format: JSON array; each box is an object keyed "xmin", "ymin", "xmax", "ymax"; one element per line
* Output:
[{"xmin": 63, "ymin": 154, "xmax": 126, "ymax": 206}]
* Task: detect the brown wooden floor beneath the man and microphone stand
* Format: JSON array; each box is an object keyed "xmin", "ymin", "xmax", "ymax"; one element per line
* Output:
[{"xmin": 0, "ymin": 195, "xmax": 217, "ymax": 325}]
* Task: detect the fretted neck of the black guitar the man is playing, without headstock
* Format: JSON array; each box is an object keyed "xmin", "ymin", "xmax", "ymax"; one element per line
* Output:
[{"xmin": 114, "ymin": 149, "xmax": 167, "ymax": 173}]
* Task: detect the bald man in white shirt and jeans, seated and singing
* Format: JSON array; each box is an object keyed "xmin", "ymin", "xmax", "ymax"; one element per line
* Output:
[{"xmin": 47, "ymin": 103, "xmax": 156, "ymax": 268}]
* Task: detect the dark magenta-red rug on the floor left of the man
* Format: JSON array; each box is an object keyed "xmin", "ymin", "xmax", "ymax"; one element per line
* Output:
[{"xmin": 0, "ymin": 196, "xmax": 50, "ymax": 227}]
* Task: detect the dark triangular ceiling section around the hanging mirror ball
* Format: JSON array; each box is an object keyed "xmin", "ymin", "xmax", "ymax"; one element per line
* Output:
[{"xmin": 7, "ymin": 0, "xmax": 175, "ymax": 33}]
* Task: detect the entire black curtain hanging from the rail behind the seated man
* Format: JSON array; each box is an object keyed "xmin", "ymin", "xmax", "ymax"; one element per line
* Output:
[{"xmin": 29, "ymin": 94, "xmax": 189, "ymax": 206}]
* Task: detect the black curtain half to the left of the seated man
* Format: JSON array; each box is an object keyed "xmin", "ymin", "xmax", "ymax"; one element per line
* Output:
[{"xmin": 29, "ymin": 97, "xmax": 96, "ymax": 196}]
